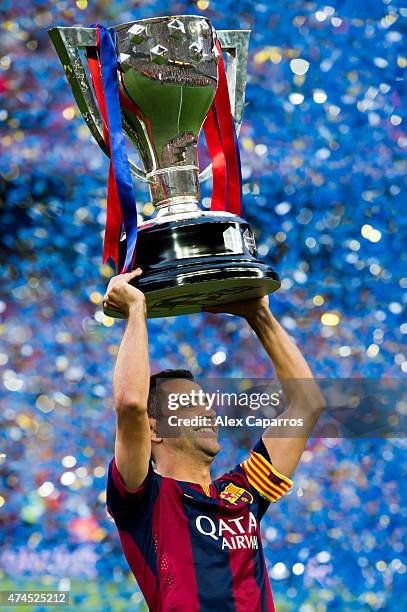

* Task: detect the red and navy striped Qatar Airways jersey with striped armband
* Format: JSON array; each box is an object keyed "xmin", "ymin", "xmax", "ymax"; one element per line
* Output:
[{"xmin": 107, "ymin": 440, "xmax": 293, "ymax": 612}]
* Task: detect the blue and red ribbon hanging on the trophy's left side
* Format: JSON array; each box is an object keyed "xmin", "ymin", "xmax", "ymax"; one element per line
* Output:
[{"xmin": 86, "ymin": 25, "xmax": 137, "ymax": 273}]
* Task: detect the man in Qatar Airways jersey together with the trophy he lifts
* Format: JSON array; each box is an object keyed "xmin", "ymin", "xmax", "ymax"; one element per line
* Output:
[{"xmin": 47, "ymin": 16, "xmax": 324, "ymax": 612}]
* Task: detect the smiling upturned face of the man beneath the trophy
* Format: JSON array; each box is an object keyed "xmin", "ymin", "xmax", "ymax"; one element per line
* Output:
[{"xmin": 158, "ymin": 378, "xmax": 220, "ymax": 458}]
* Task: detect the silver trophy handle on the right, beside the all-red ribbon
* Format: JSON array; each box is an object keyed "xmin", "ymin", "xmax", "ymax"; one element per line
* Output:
[{"xmin": 199, "ymin": 30, "xmax": 250, "ymax": 182}]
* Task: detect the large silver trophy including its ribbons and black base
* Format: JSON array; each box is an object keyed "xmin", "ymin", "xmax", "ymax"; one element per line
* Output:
[{"xmin": 50, "ymin": 16, "xmax": 280, "ymax": 317}]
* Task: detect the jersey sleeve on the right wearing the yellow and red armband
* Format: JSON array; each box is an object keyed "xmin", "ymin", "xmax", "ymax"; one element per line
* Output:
[{"xmin": 240, "ymin": 438, "xmax": 294, "ymax": 519}]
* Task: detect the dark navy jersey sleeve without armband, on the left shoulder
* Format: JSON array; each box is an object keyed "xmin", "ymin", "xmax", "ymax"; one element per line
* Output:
[{"xmin": 106, "ymin": 457, "xmax": 159, "ymax": 530}]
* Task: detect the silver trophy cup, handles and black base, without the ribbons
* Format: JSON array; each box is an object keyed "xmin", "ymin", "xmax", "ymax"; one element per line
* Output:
[{"xmin": 49, "ymin": 16, "xmax": 280, "ymax": 317}]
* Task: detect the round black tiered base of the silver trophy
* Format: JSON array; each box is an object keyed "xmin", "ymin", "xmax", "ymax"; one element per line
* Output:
[{"xmin": 104, "ymin": 212, "xmax": 280, "ymax": 319}]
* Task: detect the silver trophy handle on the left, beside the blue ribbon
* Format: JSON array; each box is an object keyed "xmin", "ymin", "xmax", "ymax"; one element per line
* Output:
[{"xmin": 48, "ymin": 27, "xmax": 148, "ymax": 181}]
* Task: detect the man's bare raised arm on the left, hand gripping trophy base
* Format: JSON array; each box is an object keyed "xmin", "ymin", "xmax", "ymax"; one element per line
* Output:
[{"xmin": 103, "ymin": 269, "xmax": 151, "ymax": 490}]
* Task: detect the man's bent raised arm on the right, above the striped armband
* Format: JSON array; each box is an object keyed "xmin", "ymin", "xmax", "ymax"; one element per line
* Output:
[{"xmin": 206, "ymin": 297, "xmax": 325, "ymax": 477}]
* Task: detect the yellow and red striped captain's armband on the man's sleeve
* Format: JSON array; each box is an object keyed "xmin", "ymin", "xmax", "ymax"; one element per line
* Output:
[{"xmin": 240, "ymin": 451, "xmax": 294, "ymax": 502}]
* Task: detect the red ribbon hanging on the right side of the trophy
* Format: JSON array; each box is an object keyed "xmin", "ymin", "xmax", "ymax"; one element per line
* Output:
[{"xmin": 203, "ymin": 41, "xmax": 242, "ymax": 216}]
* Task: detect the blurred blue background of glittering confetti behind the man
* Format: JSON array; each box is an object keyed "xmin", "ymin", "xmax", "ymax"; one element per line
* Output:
[{"xmin": 0, "ymin": 0, "xmax": 407, "ymax": 612}]
